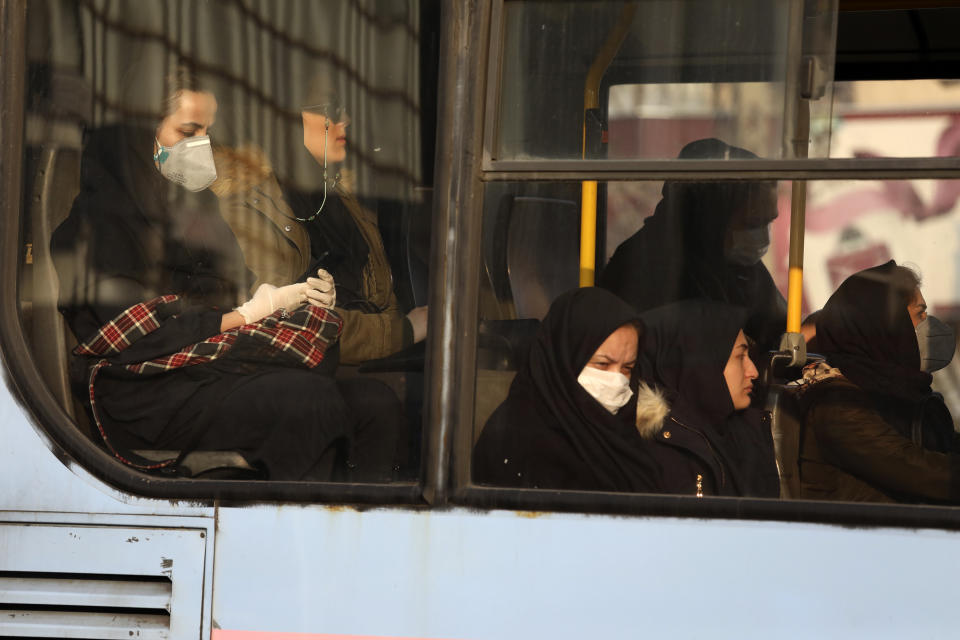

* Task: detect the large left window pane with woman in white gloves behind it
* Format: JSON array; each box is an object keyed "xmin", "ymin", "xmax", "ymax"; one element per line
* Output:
[{"xmin": 20, "ymin": 0, "xmax": 439, "ymax": 482}]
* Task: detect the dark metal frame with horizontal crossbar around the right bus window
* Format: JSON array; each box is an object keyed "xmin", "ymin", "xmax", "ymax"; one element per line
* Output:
[{"xmin": 454, "ymin": 0, "xmax": 960, "ymax": 530}]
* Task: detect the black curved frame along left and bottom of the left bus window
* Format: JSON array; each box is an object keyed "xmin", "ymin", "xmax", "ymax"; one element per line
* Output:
[{"xmin": 0, "ymin": 0, "xmax": 442, "ymax": 508}]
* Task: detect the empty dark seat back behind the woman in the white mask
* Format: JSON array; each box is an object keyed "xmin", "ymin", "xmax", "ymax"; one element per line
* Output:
[{"xmin": 492, "ymin": 195, "xmax": 580, "ymax": 320}]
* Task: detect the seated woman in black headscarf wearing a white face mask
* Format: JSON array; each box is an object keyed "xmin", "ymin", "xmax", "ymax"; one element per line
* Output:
[{"xmin": 473, "ymin": 288, "xmax": 658, "ymax": 492}]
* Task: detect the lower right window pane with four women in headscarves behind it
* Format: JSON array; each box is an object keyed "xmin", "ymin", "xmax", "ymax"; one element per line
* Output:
[{"xmin": 472, "ymin": 175, "xmax": 960, "ymax": 504}]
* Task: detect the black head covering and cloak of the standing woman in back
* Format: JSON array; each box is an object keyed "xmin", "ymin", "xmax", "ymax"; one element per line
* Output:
[{"xmin": 600, "ymin": 138, "xmax": 786, "ymax": 348}]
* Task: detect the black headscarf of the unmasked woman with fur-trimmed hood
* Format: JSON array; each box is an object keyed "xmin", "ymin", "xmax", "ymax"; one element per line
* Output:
[{"xmin": 641, "ymin": 300, "xmax": 779, "ymax": 497}]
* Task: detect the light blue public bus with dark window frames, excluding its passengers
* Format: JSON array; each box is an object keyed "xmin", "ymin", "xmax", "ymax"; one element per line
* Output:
[{"xmin": 0, "ymin": 0, "xmax": 960, "ymax": 640}]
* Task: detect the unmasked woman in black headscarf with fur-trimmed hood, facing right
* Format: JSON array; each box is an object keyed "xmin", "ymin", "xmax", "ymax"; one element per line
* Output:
[{"xmin": 637, "ymin": 300, "xmax": 780, "ymax": 498}]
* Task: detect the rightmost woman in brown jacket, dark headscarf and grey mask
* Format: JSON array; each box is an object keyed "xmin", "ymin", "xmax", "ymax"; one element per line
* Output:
[{"xmin": 797, "ymin": 260, "xmax": 960, "ymax": 503}]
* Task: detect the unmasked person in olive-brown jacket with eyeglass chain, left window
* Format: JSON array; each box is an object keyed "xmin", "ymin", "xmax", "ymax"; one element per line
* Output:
[{"xmin": 214, "ymin": 77, "xmax": 427, "ymax": 365}]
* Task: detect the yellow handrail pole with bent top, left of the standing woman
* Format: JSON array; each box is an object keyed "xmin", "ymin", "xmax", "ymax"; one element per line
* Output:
[{"xmin": 580, "ymin": 3, "xmax": 637, "ymax": 287}]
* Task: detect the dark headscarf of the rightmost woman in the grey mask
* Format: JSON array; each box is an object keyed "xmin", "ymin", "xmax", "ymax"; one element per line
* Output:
[{"xmin": 817, "ymin": 260, "xmax": 932, "ymax": 401}]
